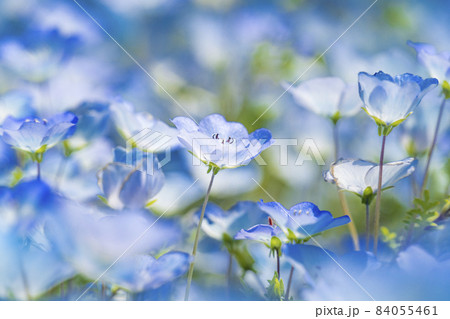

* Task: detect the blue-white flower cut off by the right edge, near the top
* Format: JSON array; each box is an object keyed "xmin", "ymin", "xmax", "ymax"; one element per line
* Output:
[{"xmin": 408, "ymin": 41, "xmax": 450, "ymax": 83}]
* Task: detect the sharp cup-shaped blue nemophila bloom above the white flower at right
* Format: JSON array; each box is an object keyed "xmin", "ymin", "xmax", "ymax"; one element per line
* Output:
[{"xmin": 358, "ymin": 71, "xmax": 438, "ymax": 135}]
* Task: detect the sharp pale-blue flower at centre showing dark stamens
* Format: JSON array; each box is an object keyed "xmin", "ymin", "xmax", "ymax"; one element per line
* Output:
[{"xmin": 172, "ymin": 114, "xmax": 273, "ymax": 169}]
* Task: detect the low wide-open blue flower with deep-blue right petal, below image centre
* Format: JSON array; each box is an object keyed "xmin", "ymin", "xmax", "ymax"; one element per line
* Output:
[{"xmin": 235, "ymin": 201, "xmax": 350, "ymax": 242}]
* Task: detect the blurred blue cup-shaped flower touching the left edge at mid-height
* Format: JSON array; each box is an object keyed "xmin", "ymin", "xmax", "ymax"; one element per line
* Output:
[{"xmin": 1, "ymin": 112, "xmax": 78, "ymax": 155}]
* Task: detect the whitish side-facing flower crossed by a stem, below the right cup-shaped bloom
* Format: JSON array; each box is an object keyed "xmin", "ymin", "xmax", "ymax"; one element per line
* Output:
[{"xmin": 323, "ymin": 157, "xmax": 417, "ymax": 203}]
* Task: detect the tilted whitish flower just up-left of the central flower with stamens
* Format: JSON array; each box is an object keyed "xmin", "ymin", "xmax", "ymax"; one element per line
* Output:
[{"xmin": 110, "ymin": 98, "xmax": 179, "ymax": 153}]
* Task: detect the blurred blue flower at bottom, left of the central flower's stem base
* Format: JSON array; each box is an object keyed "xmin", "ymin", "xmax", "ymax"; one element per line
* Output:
[{"xmin": 105, "ymin": 252, "xmax": 190, "ymax": 293}]
